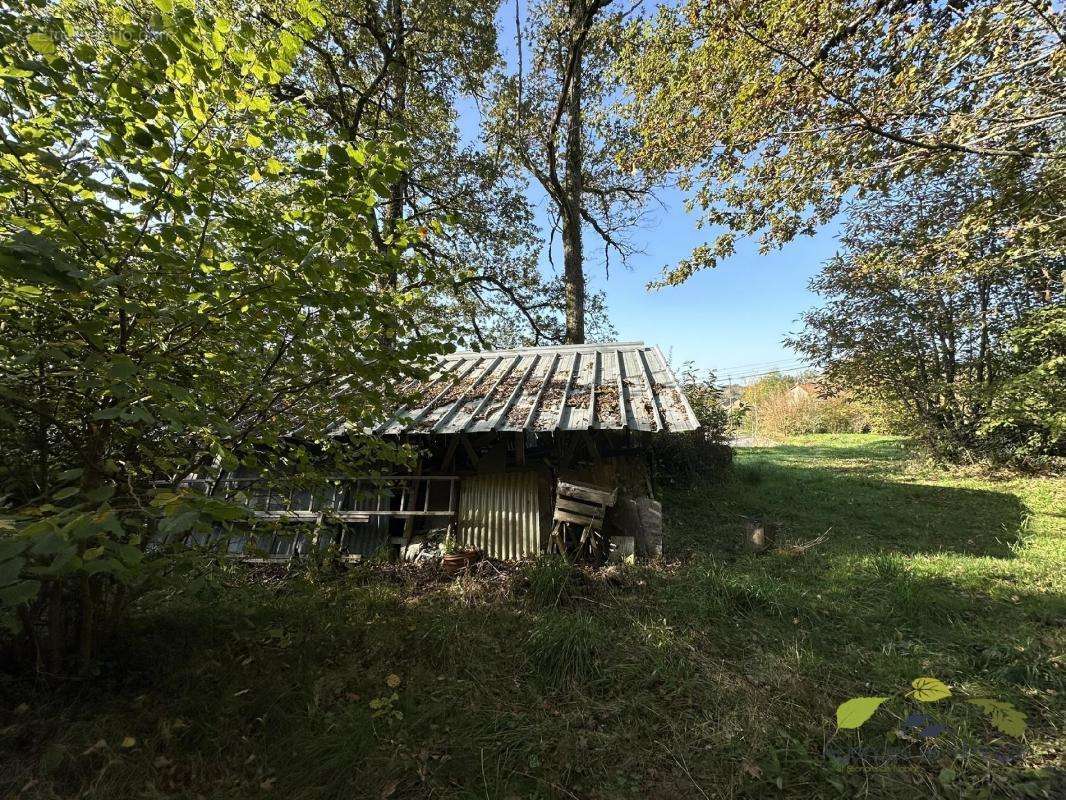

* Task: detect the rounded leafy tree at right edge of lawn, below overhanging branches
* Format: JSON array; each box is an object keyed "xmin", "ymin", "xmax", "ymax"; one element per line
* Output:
[{"xmin": 789, "ymin": 162, "xmax": 1066, "ymax": 453}]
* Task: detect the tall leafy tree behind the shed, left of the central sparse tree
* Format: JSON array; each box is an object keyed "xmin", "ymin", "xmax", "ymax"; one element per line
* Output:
[{"xmin": 263, "ymin": 0, "xmax": 575, "ymax": 346}]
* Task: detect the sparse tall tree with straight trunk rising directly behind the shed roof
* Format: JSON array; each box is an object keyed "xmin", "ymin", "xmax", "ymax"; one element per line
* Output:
[{"xmin": 489, "ymin": 0, "xmax": 652, "ymax": 343}]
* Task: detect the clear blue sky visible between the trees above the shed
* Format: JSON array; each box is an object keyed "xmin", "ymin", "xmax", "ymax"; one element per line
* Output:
[{"xmin": 459, "ymin": 2, "xmax": 837, "ymax": 382}]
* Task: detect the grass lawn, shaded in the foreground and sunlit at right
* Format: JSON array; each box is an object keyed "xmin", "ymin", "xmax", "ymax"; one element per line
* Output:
[{"xmin": 0, "ymin": 435, "xmax": 1066, "ymax": 800}]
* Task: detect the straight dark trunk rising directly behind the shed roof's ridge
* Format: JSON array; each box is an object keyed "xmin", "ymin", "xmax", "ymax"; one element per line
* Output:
[{"xmin": 562, "ymin": 0, "xmax": 585, "ymax": 345}]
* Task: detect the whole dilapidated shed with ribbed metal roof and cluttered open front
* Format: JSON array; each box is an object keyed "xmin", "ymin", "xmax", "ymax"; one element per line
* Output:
[{"xmin": 194, "ymin": 341, "xmax": 699, "ymax": 559}]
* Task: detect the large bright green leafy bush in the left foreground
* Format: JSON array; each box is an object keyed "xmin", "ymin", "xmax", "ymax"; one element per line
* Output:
[{"xmin": 0, "ymin": 0, "xmax": 440, "ymax": 674}]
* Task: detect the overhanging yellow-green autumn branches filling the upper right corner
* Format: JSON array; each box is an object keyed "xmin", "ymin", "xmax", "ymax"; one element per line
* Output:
[{"xmin": 621, "ymin": 0, "xmax": 1066, "ymax": 283}]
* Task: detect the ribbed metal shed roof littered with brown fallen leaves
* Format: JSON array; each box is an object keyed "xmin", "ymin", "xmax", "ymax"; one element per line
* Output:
[{"xmin": 373, "ymin": 341, "xmax": 699, "ymax": 434}]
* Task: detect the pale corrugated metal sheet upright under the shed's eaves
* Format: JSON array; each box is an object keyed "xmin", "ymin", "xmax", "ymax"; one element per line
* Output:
[{"xmin": 459, "ymin": 473, "xmax": 540, "ymax": 559}]
